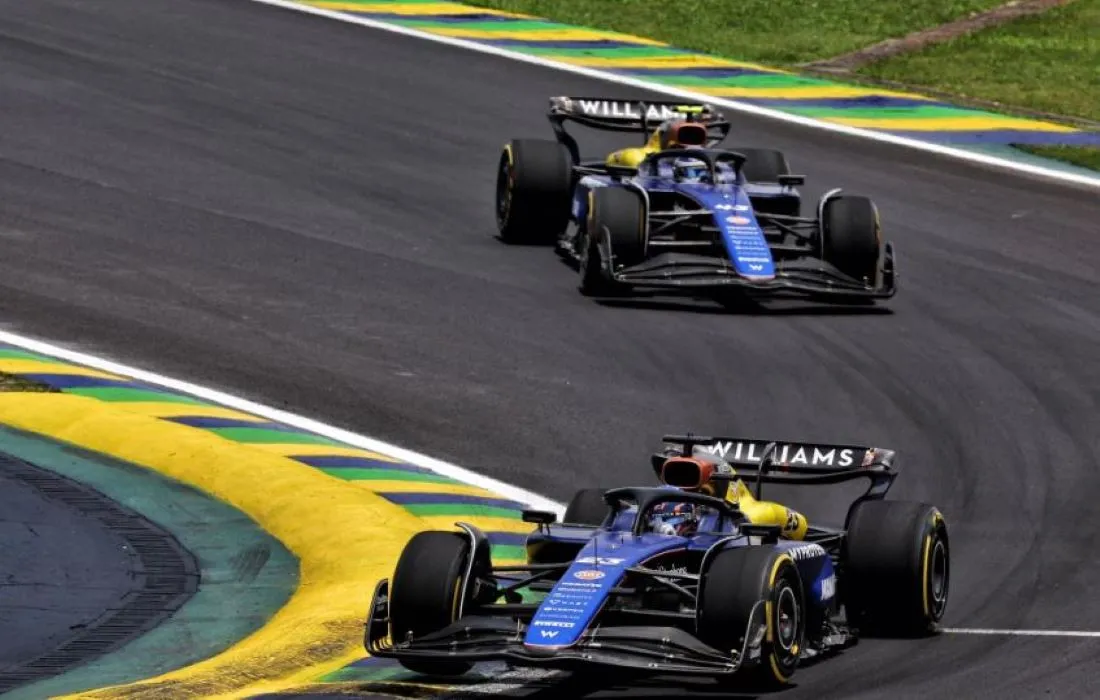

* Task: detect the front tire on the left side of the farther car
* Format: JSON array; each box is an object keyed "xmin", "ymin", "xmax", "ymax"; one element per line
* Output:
[{"xmin": 578, "ymin": 187, "xmax": 648, "ymax": 296}]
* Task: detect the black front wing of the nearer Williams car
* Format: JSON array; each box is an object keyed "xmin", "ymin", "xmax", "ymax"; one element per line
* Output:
[{"xmin": 364, "ymin": 580, "xmax": 767, "ymax": 676}]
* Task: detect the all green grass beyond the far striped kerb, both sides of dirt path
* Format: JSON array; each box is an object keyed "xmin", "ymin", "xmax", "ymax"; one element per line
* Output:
[{"xmin": 466, "ymin": 0, "xmax": 1100, "ymax": 169}]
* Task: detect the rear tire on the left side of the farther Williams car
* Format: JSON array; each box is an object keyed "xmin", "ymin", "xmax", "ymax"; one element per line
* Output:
[{"xmin": 496, "ymin": 139, "xmax": 573, "ymax": 244}]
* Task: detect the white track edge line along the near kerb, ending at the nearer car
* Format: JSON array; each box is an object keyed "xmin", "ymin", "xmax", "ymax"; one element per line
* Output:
[{"xmin": 0, "ymin": 330, "xmax": 565, "ymax": 516}]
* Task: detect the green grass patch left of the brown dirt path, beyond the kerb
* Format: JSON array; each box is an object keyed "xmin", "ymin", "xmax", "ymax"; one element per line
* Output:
[{"xmin": 466, "ymin": 0, "xmax": 1003, "ymax": 65}]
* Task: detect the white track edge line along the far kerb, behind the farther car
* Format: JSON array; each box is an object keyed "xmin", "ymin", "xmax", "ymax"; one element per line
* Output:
[{"xmin": 245, "ymin": 0, "xmax": 1100, "ymax": 188}]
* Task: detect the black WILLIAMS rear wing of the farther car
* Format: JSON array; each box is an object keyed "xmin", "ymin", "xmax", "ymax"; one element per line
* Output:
[{"xmin": 547, "ymin": 96, "xmax": 730, "ymax": 163}]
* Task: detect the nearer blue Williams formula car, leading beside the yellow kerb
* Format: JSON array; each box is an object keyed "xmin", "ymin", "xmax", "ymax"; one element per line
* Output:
[{"xmin": 364, "ymin": 436, "xmax": 949, "ymax": 685}]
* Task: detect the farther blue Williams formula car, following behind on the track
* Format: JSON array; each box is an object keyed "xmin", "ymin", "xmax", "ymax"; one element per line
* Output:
[{"xmin": 496, "ymin": 97, "xmax": 897, "ymax": 303}]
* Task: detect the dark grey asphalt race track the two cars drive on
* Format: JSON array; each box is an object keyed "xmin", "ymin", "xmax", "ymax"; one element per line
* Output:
[{"xmin": 0, "ymin": 0, "xmax": 1100, "ymax": 698}]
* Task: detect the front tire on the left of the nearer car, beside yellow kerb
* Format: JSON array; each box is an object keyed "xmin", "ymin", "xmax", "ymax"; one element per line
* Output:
[{"xmin": 389, "ymin": 531, "xmax": 473, "ymax": 676}]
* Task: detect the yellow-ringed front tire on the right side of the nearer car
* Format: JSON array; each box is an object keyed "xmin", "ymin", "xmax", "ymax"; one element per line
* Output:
[{"xmin": 695, "ymin": 547, "xmax": 806, "ymax": 688}]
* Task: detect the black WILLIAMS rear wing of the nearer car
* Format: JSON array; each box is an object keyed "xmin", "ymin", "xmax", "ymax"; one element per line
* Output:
[{"xmin": 652, "ymin": 435, "xmax": 898, "ymax": 499}]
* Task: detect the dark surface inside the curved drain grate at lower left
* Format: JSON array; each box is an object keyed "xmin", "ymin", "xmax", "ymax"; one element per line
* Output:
[{"xmin": 0, "ymin": 456, "xmax": 135, "ymax": 693}]
